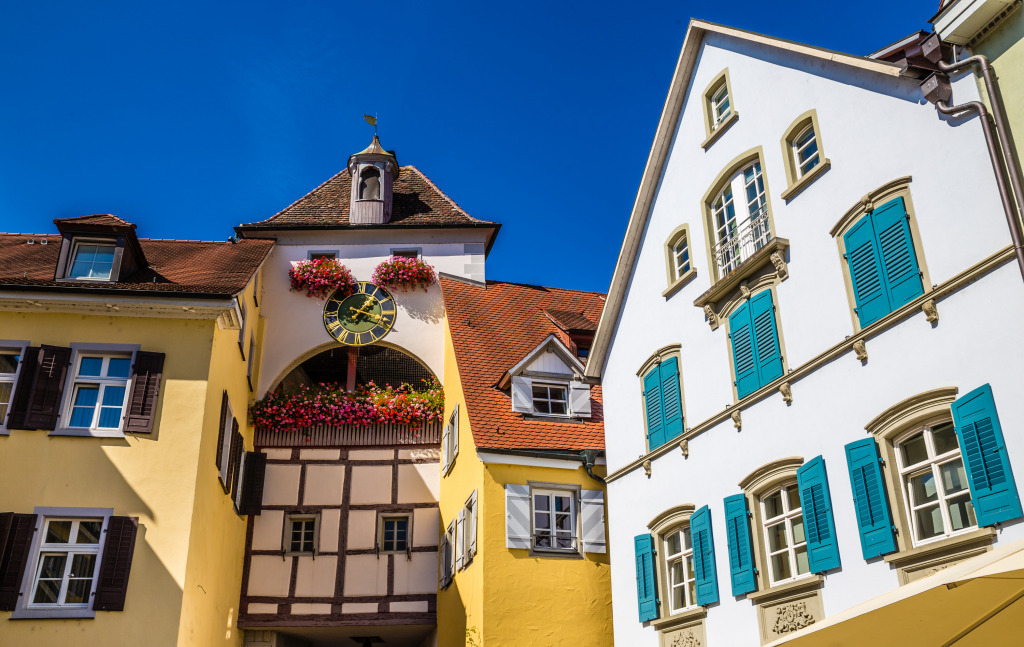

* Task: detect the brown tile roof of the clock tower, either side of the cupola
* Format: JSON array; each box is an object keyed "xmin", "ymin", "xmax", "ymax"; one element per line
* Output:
[{"xmin": 238, "ymin": 166, "xmax": 498, "ymax": 231}]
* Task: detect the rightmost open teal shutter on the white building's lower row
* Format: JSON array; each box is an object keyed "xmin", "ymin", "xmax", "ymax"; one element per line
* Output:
[{"xmin": 952, "ymin": 384, "xmax": 1024, "ymax": 526}]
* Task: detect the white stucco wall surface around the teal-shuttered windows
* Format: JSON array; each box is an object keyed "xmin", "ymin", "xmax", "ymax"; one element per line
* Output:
[{"xmin": 602, "ymin": 34, "xmax": 1024, "ymax": 646}]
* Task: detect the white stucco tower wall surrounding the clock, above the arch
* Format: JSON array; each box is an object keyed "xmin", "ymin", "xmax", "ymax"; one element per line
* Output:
[{"xmin": 256, "ymin": 227, "xmax": 486, "ymax": 397}]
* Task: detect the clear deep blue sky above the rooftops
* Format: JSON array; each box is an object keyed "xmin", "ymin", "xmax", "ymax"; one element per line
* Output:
[{"xmin": 0, "ymin": 0, "xmax": 938, "ymax": 291}]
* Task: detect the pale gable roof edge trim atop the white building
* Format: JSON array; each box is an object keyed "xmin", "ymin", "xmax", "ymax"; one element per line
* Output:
[{"xmin": 587, "ymin": 19, "xmax": 901, "ymax": 377}]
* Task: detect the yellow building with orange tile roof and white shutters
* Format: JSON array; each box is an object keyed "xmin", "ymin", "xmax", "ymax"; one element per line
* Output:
[{"xmin": 437, "ymin": 277, "xmax": 612, "ymax": 647}]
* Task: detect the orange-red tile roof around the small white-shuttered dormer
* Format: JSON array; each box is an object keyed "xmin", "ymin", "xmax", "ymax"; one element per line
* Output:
[{"xmin": 440, "ymin": 276, "xmax": 604, "ymax": 450}]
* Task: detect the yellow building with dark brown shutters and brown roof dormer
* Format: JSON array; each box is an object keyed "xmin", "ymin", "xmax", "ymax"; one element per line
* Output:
[{"xmin": 0, "ymin": 215, "xmax": 273, "ymax": 647}]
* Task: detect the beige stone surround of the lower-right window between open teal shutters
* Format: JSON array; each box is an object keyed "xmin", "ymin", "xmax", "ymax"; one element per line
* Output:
[{"xmin": 864, "ymin": 386, "xmax": 995, "ymax": 586}]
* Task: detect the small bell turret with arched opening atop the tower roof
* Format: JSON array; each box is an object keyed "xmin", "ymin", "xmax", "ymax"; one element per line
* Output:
[{"xmin": 348, "ymin": 135, "xmax": 398, "ymax": 224}]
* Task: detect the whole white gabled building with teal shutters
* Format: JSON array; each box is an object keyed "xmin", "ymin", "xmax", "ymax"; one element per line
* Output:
[{"xmin": 588, "ymin": 21, "xmax": 1024, "ymax": 647}]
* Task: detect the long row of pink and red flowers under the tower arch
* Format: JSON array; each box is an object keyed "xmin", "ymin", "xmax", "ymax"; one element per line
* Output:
[{"xmin": 249, "ymin": 378, "xmax": 444, "ymax": 432}]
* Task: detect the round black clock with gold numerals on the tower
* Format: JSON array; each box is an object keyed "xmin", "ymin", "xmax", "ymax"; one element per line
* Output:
[{"xmin": 324, "ymin": 282, "xmax": 397, "ymax": 346}]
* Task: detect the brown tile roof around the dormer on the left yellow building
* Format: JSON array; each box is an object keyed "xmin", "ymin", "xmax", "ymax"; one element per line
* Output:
[{"xmin": 0, "ymin": 232, "xmax": 273, "ymax": 295}]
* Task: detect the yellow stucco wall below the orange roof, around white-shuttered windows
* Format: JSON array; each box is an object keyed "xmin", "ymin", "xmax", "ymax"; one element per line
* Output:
[{"xmin": 437, "ymin": 315, "xmax": 612, "ymax": 647}]
